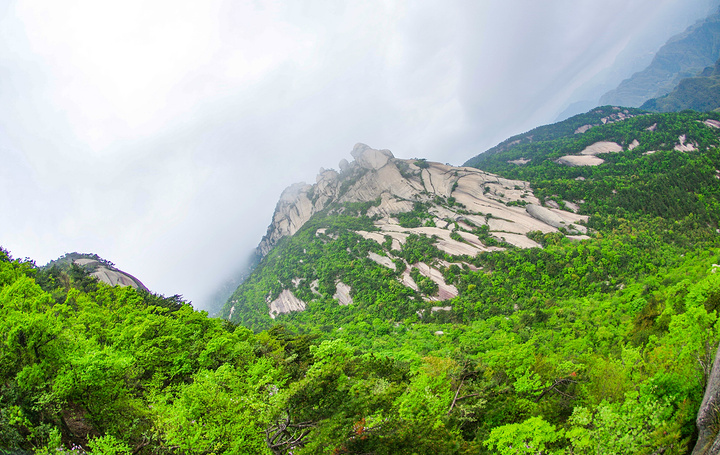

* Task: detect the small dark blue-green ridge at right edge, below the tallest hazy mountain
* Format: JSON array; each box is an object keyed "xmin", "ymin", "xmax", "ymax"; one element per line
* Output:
[{"xmin": 642, "ymin": 60, "xmax": 720, "ymax": 112}]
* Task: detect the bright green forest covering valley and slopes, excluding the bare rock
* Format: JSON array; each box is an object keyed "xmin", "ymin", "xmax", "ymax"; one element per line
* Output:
[{"xmin": 0, "ymin": 108, "xmax": 720, "ymax": 455}]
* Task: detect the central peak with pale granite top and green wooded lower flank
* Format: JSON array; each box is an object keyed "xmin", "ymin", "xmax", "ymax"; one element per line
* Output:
[{"xmin": 222, "ymin": 144, "xmax": 587, "ymax": 323}]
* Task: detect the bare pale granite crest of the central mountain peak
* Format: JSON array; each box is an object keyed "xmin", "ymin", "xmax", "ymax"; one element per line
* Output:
[{"xmin": 258, "ymin": 144, "xmax": 584, "ymax": 257}]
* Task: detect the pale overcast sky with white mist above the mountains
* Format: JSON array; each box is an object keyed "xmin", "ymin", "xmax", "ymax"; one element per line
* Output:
[{"xmin": 0, "ymin": 0, "xmax": 718, "ymax": 308}]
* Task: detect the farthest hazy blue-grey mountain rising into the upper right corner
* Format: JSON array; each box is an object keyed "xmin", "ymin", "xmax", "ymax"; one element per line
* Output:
[{"xmin": 600, "ymin": 10, "xmax": 720, "ymax": 107}]
